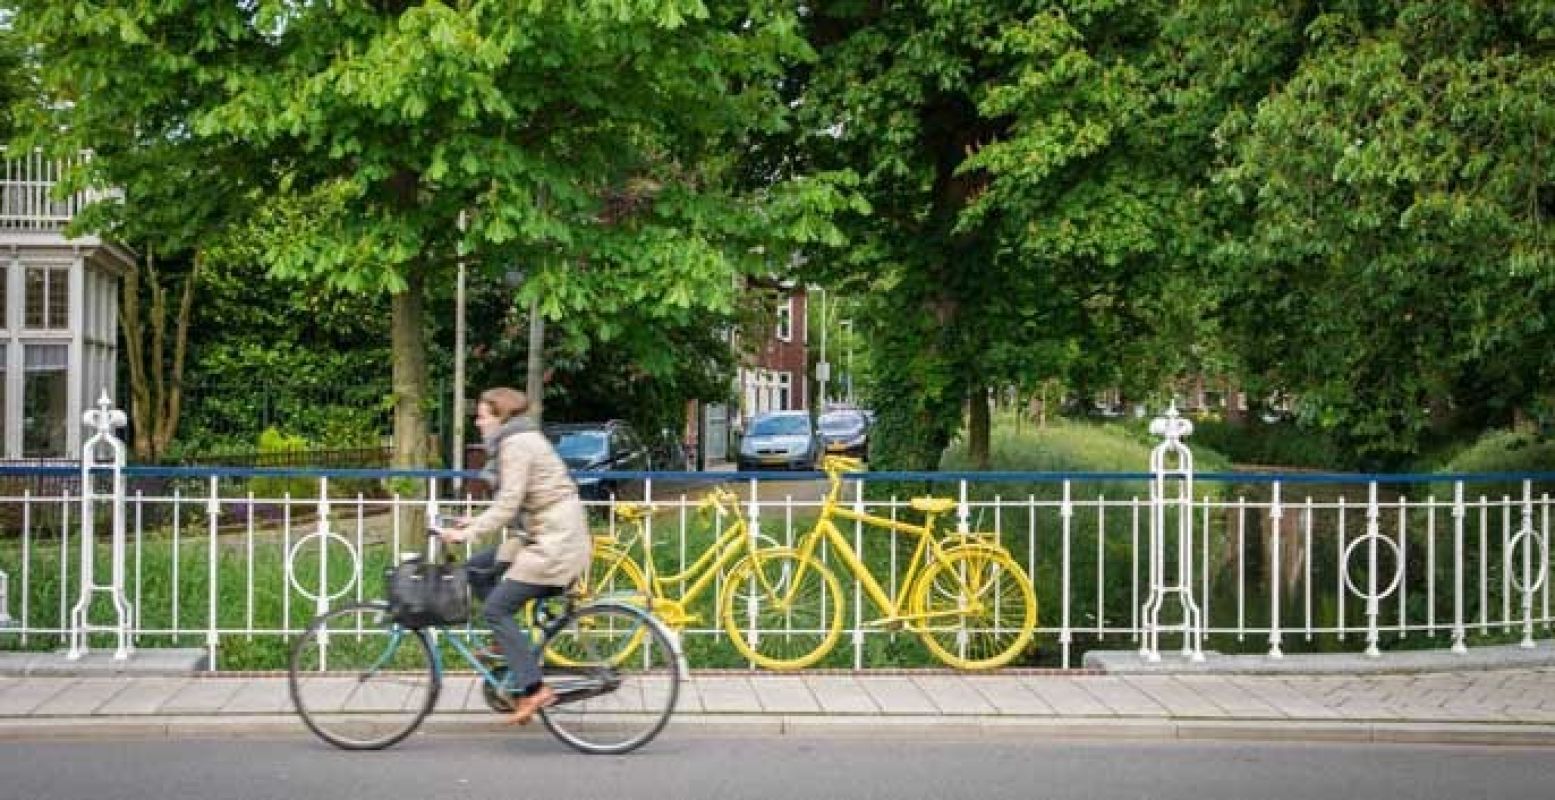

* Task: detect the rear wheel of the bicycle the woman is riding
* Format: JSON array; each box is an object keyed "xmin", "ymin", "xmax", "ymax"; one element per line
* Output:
[{"xmin": 540, "ymin": 602, "xmax": 684, "ymax": 755}]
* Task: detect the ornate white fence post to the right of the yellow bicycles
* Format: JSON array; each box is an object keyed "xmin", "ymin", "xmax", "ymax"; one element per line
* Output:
[{"xmin": 1140, "ymin": 402, "xmax": 1204, "ymax": 661}]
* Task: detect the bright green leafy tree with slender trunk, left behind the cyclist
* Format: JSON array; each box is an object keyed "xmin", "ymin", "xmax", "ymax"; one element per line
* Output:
[{"xmin": 17, "ymin": 0, "xmax": 847, "ymax": 465}]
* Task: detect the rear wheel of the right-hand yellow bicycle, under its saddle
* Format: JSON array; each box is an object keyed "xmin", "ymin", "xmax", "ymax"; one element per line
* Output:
[{"xmin": 908, "ymin": 545, "xmax": 1037, "ymax": 669}]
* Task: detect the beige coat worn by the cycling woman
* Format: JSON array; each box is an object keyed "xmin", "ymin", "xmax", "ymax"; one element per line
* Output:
[{"xmin": 467, "ymin": 431, "xmax": 592, "ymax": 587}]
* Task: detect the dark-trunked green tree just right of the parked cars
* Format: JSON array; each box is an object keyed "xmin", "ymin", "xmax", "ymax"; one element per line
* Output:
[{"xmin": 798, "ymin": 0, "xmax": 1218, "ymax": 468}]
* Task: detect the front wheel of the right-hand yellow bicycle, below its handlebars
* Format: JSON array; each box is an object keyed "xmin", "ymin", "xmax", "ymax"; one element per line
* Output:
[{"xmin": 718, "ymin": 548, "xmax": 843, "ymax": 669}]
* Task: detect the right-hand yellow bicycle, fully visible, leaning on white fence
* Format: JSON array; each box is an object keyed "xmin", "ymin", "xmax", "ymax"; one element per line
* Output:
[{"xmin": 720, "ymin": 456, "xmax": 1037, "ymax": 669}]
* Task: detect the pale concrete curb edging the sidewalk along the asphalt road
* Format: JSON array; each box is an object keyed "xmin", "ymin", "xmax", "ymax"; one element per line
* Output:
[{"xmin": 0, "ymin": 713, "xmax": 1555, "ymax": 747}]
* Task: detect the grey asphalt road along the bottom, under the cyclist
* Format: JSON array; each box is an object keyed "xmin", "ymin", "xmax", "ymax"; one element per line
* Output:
[{"xmin": 0, "ymin": 730, "xmax": 1555, "ymax": 800}]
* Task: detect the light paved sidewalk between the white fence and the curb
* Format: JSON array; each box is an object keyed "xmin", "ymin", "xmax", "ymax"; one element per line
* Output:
[{"xmin": 0, "ymin": 666, "xmax": 1555, "ymax": 746}]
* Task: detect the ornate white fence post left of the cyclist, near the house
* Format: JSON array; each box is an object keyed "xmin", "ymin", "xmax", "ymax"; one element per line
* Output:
[{"xmin": 65, "ymin": 391, "xmax": 132, "ymax": 661}]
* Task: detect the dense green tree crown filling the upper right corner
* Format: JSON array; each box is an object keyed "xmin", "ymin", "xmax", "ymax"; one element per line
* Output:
[{"xmin": 1218, "ymin": 0, "xmax": 1555, "ymax": 464}]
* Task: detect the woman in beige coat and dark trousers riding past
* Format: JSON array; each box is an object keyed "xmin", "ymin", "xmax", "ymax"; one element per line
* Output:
[{"xmin": 440, "ymin": 388, "xmax": 591, "ymax": 725}]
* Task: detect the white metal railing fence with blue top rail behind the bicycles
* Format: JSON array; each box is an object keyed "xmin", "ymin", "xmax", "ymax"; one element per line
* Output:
[{"xmin": 0, "ymin": 404, "xmax": 1555, "ymax": 669}]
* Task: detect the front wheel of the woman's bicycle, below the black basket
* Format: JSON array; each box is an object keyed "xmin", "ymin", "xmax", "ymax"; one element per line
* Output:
[{"xmin": 288, "ymin": 602, "xmax": 439, "ymax": 750}]
